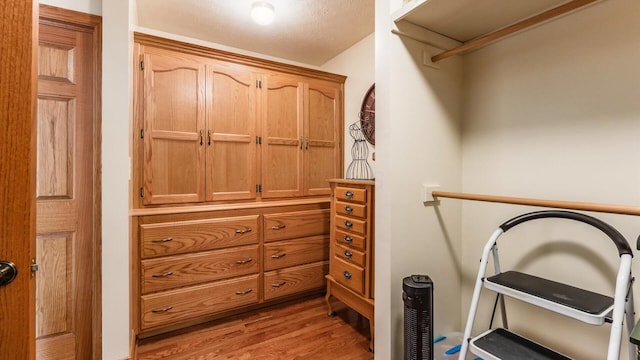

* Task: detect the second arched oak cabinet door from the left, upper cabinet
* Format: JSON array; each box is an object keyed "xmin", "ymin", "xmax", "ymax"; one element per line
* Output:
[{"xmin": 206, "ymin": 62, "xmax": 258, "ymax": 200}]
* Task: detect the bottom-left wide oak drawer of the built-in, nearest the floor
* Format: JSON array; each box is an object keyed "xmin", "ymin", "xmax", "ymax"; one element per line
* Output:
[{"xmin": 140, "ymin": 274, "xmax": 258, "ymax": 330}]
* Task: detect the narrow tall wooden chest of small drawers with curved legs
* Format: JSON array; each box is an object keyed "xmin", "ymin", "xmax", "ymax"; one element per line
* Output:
[{"xmin": 326, "ymin": 179, "xmax": 375, "ymax": 351}]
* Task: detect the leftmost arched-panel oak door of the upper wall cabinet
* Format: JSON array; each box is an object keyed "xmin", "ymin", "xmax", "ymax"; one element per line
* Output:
[{"xmin": 141, "ymin": 47, "xmax": 205, "ymax": 204}]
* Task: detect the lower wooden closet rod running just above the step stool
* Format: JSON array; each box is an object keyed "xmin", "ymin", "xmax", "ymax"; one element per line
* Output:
[{"xmin": 432, "ymin": 191, "xmax": 640, "ymax": 216}]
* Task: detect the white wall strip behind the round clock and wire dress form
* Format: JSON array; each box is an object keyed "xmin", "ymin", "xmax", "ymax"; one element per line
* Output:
[{"xmin": 320, "ymin": 33, "xmax": 375, "ymax": 176}]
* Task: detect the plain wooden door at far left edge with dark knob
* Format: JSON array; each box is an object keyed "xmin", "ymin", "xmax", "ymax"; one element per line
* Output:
[{"xmin": 0, "ymin": 0, "xmax": 38, "ymax": 360}]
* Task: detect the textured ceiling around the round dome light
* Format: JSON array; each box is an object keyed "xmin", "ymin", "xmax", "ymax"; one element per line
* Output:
[{"xmin": 137, "ymin": 0, "xmax": 374, "ymax": 66}]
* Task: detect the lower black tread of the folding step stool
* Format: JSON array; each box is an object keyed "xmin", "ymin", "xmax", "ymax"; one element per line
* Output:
[{"xmin": 471, "ymin": 328, "xmax": 571, "ymax": 360}]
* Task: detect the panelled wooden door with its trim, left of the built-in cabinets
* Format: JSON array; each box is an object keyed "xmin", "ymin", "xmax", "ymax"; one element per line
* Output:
[{"xmin": 35, "ymin": 6, "xmax": 100, "ymax": 360}]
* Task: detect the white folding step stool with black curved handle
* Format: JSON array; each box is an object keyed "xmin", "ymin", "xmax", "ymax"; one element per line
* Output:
[{"xmin": 459, "ymin": 210, "xmax": 636, "ymax": 360}]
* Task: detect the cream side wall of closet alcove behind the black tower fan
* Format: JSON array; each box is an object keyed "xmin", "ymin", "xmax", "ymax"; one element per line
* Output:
[{"xmin": 375, "ymin": 0, "xmax": 462, "ymax": 359}]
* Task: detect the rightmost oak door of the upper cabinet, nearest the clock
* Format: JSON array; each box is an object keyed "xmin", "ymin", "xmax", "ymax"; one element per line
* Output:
[{"xmin": 303, "ymin": 81, "xmax": 342, "ymax": 195}]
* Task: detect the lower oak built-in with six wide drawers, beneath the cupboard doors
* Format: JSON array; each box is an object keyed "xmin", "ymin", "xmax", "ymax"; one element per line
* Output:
[{"xmin": 132, "ymin": 201, "xmax": 330, "ymax": 337}]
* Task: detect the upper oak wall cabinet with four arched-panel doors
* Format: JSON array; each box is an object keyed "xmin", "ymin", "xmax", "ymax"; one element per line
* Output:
[{"xmin": 133, "ymin": 34, "xmax": 345, "ymax": 207}]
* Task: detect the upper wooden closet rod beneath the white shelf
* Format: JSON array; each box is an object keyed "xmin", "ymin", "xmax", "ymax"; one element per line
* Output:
[{"xmin": 431, "ymin": 0, "xmax": 599, "ymax": 62}]
